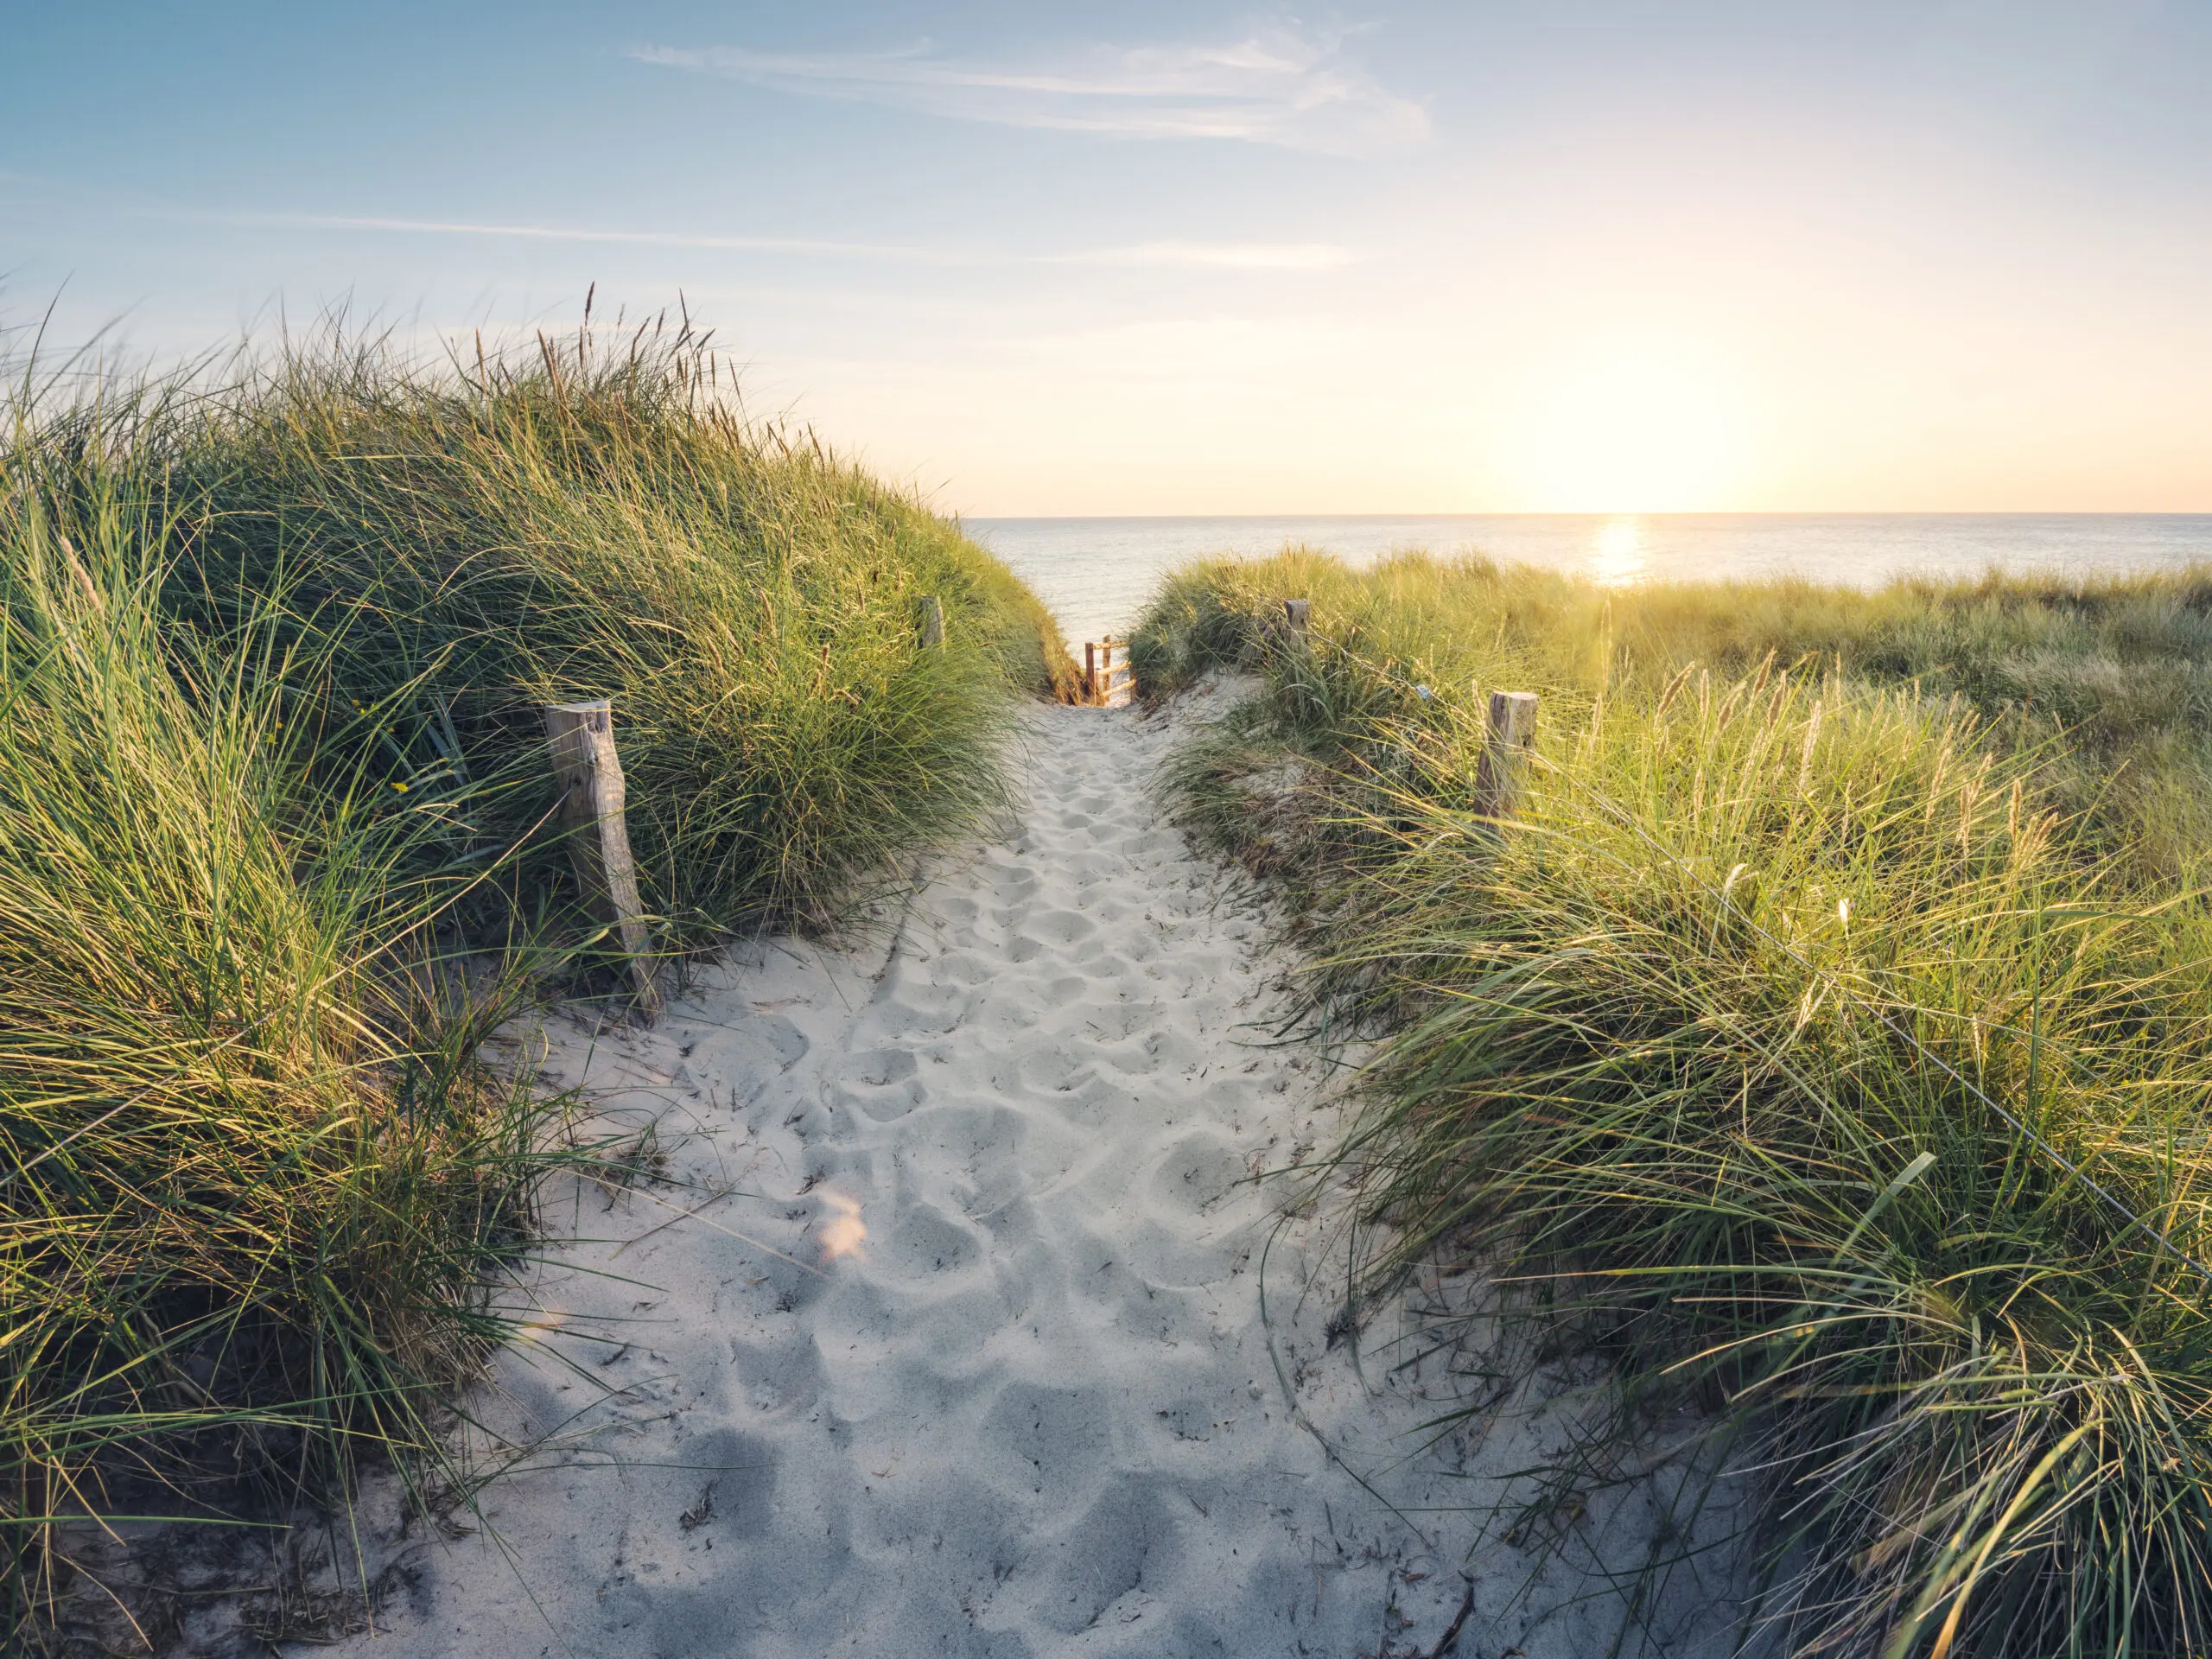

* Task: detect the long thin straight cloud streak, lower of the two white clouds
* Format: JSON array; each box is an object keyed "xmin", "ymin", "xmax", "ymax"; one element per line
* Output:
[{"xmin": 238, "ymin": 213, "xmax": 1360, "ymax": 270}]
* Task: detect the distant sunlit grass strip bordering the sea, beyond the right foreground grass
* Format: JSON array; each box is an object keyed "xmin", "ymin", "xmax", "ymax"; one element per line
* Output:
[{"xmin": 1133, "ymin": 549, "xmax": 2212, "ymax": 878}]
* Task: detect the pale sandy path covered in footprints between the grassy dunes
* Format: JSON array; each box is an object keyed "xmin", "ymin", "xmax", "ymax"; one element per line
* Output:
[{"xmin": 322, "ymin": 690, "xmax": 1743, "ymax": 1659}]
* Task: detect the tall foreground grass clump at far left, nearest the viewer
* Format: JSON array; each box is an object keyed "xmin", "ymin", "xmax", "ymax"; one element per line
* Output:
[{"xmin": 0, "ymin": 393, "xmax": 577, "ymax": 1650}]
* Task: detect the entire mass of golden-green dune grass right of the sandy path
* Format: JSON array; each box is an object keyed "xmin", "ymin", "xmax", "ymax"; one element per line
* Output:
[{"xmin": 1137, "ymin": 556, "xmax": 2212, "ymax": 1656}]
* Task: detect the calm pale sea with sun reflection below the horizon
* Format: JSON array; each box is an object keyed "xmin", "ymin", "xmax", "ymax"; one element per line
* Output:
[{"xmin": 964, "ymin": 513, "xmax": 2212, "ymax": 648}]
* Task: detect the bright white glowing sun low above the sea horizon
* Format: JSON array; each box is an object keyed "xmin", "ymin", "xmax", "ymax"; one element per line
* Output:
[{"xmin": 1517, "ymin": 347, "xmax": 1752, "ymax": 513}]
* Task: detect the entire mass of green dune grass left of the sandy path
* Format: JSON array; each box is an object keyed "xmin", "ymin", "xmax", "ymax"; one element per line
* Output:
[{"xmin": 0, "ymin": 336, "xmax": 1071, "ymax": 1652}]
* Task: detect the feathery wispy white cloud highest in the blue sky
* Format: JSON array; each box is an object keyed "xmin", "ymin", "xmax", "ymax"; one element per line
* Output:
[{"xmin": 628, "ymin": 24, "xmax": 1429, "ymax": 155}]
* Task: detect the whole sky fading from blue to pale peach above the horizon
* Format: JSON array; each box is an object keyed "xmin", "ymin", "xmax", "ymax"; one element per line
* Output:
[{"xmin": 0, "ymin": 0, "xmax": 2212, "ymax": 515}]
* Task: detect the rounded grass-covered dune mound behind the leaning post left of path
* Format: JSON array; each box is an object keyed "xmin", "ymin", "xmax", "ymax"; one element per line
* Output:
[{"xmin": 163, "ymin": 329, "xmax": 1073, "ymax": 949}]
